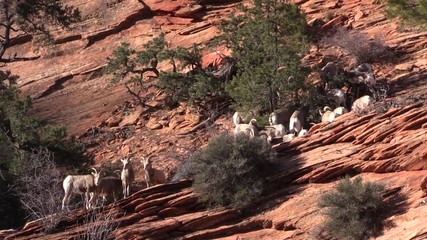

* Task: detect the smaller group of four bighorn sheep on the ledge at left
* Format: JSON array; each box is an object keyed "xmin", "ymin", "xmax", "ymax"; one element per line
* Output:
[{"xmin": 62, "ymin": 155, "xmax": 155, "ymax": 210}]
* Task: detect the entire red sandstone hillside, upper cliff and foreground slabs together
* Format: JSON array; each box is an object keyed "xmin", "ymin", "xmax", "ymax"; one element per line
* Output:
[{"xmin": 0, "ymin": 0, "xmax": 427, "ymax": 239}]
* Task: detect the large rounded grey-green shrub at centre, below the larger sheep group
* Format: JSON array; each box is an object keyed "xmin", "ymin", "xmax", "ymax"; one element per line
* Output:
[{"xmin": 184, "ymin": 133, "xmax": 275, "ymax": 209}]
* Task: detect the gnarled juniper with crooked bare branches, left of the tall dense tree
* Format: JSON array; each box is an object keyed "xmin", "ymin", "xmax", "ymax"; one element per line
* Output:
[{"xmin": 105, "ymin": 34, "xmax": 225, "ymax": 108}]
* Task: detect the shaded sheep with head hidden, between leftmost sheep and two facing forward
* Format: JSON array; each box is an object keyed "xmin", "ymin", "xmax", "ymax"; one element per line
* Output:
[{"xmin": 96, "ymin": 177, "xmax": 123, "ymax": 202}]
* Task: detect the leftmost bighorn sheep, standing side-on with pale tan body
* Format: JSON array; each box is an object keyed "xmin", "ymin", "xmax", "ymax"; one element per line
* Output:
[{"xmin": 62, "ymin": 168, "xmax": 101, "ymax": 209}]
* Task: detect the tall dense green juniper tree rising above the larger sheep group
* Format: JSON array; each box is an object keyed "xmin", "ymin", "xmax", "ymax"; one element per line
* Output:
[{"xmin": 220, "ymin": 0, "xmax": 306, "ymax": 111}]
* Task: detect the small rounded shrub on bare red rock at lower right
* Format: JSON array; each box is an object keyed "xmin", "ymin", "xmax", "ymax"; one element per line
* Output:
[{"xmin": 319, "ymin": 177, "xmax": 386, "ymax": 240}]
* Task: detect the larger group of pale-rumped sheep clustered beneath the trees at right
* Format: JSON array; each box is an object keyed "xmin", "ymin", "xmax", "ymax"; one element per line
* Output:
[{"xmin": 233, "ymin": 62, "xmax": 380, "ymax": 143}]
